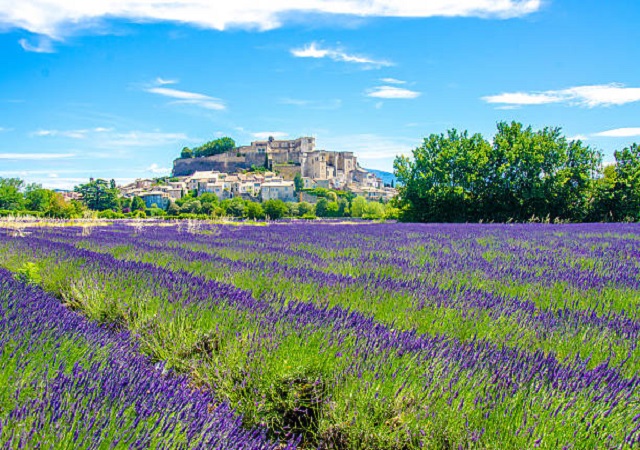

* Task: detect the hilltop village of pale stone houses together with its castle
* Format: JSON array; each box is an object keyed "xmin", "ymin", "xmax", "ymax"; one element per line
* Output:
[{"xmin": 120, "ymin": 137, "xmax": 397, "ymax": 209}]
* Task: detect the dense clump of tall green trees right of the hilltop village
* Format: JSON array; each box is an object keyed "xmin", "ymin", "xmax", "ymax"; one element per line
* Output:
[{"xmin": 394, "ymin": 122, "xmax": 640, "ymax": 222}]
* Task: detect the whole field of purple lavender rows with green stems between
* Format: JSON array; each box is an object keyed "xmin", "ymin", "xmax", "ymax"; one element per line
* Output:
[{"xmin": 0, "ymin": 221, "xmax": 640, "ymax": 449}]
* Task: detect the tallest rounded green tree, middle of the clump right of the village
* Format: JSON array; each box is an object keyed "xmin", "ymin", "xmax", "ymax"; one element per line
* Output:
[{"xmin": 488, "ymin": 122, "xmax": 600, "ymax": 220}]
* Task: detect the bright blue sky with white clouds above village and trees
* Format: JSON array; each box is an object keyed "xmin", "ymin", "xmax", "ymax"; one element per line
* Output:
[{"xmin": 0, "ymin": 0, "xmax": 640, "ymax": 188}]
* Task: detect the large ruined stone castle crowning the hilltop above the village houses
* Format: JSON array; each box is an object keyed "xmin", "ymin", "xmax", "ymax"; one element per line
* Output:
[{"xmin": 172, "ymin": 137, "xmax": 366, "ymax": 187}]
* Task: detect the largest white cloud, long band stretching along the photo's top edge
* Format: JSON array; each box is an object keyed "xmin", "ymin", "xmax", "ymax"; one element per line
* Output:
[{"xmin": 0, "ymin": 0, "xmax": 542, "ymax": 37}]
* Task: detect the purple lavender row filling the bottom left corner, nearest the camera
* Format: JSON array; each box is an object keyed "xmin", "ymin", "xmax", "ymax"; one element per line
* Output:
[{"xmin": 0, "ymin": 270, "xmax": 293, "ymax": 449}]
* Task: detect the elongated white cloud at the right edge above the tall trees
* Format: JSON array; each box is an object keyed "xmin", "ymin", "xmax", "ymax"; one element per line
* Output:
[{"xmin": 482, "ymin": 83, "xmax": 640, "ymax": 108}]
